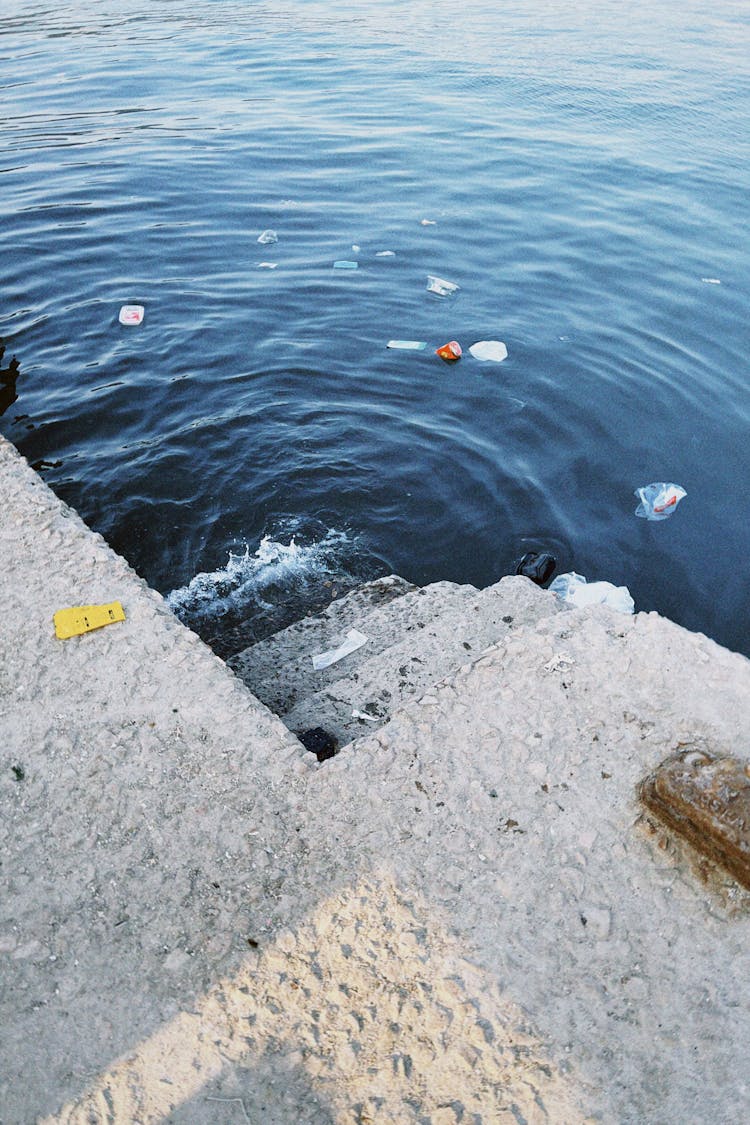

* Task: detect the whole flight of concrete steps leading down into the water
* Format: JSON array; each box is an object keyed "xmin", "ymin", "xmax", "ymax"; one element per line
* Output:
[{"xmin": 228, "ymin": 575, "xmax": 562, "ymax": 749}]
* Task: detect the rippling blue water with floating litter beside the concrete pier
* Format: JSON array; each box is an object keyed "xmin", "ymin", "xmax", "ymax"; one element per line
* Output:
[{"xmin": 0, "ymin": 0, "xmax": 750, "ymax": 653}]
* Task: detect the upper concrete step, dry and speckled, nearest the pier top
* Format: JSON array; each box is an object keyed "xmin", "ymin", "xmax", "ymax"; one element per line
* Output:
[{"xmin": 281, "ymin": 576, "xmax": 562, "ymax": 747}]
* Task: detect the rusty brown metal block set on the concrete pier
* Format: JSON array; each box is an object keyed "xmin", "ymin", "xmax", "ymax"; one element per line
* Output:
[{"xmin": 639, "ymin": 749, "xmax": 750, "ymax": 890}]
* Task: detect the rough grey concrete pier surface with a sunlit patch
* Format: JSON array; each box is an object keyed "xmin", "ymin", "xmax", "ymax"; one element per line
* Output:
[{"xmin": 0, "ymin": 439, "xmax": 750, "ymax": 1125}]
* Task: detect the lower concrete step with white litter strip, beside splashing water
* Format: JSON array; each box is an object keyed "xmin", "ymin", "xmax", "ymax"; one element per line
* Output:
[{"xmin": 228, "ymin": 575, "xmax": 476, "ymax": 714}]
